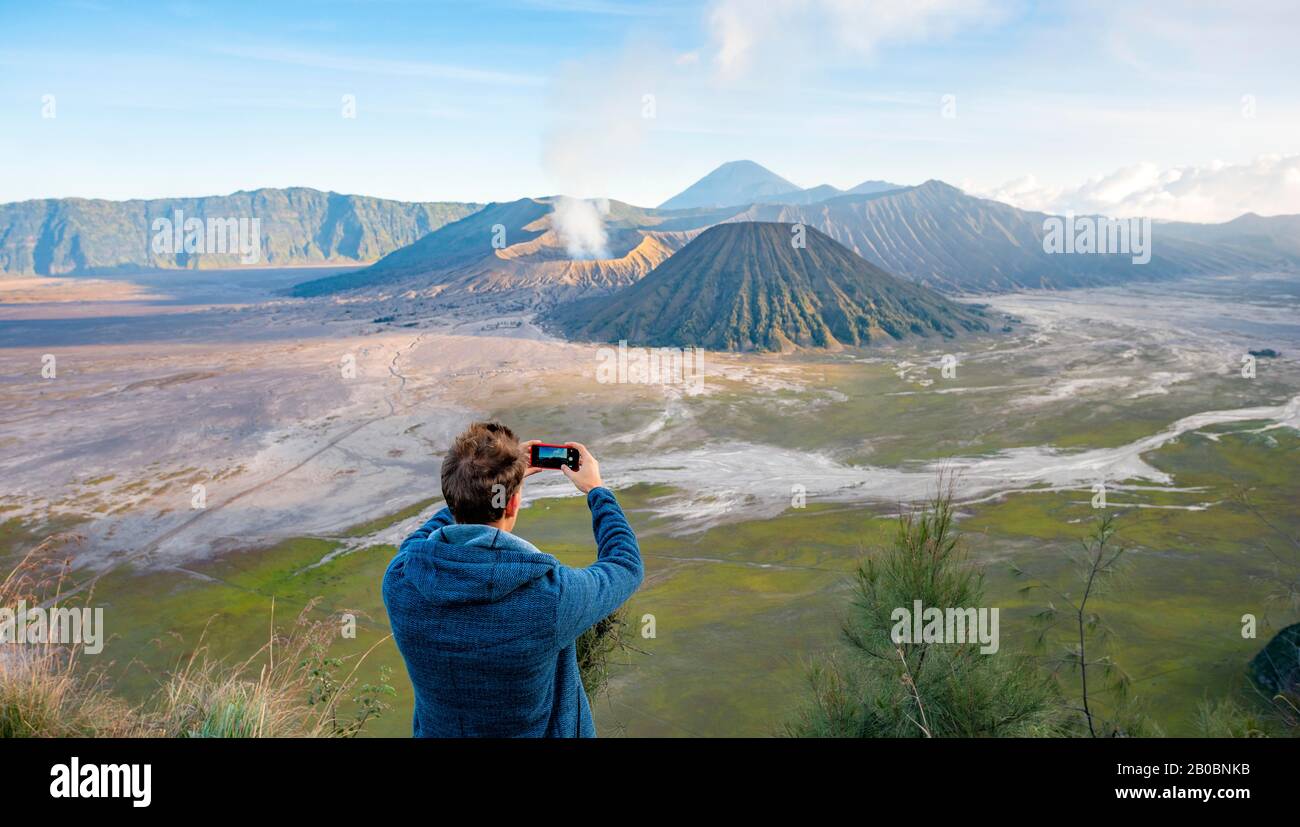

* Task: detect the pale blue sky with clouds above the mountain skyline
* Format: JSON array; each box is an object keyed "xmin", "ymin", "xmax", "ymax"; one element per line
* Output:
[{"xmin": 0, "ymin": 0, "xmax": 1300, "ymax": 217}]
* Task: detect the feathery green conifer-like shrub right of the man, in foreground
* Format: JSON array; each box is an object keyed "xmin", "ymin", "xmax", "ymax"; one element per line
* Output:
[{"xmin": 787, "ymin": 486, "xmax": 1070, "ymax": 737}]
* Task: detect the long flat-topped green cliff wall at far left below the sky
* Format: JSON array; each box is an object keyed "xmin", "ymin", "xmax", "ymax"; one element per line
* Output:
[{"xmin": 0, "ymin": 187, "xmax": 478, "ymax": 276}]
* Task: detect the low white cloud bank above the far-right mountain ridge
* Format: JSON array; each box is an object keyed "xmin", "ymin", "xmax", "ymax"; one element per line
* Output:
[{"xmin": 978, "ymin": 155, "xmax": 1300, "ymax": 221}]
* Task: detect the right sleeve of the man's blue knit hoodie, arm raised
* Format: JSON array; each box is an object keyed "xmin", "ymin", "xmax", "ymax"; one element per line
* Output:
[{"xmin": 555, "ymin": 488, "xmax": 642, "ymax": 646}]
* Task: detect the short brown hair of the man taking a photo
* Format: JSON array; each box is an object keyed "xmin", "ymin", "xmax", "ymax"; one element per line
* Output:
[{"xmin": 442, "ymin": 423, "xmax": 528, "ymax": 523}]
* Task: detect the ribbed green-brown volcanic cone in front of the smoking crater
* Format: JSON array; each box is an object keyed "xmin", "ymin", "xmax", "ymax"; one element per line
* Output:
[{"xmin": 551, "ymin": 222, "xmax": 988, "ymax": 351}]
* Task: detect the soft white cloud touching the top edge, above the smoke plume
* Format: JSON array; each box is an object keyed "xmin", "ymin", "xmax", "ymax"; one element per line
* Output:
[{"xmin": 709, "ymin": 0, "xmax": 1001, "ymax": 79}]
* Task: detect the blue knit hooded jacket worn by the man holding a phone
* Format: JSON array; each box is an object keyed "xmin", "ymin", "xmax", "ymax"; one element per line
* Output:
[{"xmin": 384, "ymin": 488, "xmax": 642, "ymax": 737}]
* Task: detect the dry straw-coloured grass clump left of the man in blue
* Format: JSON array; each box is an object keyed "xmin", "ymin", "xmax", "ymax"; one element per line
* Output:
[{"xmin": 0, "ymin": 534, "xmax": 393, "ymax": 737}]
